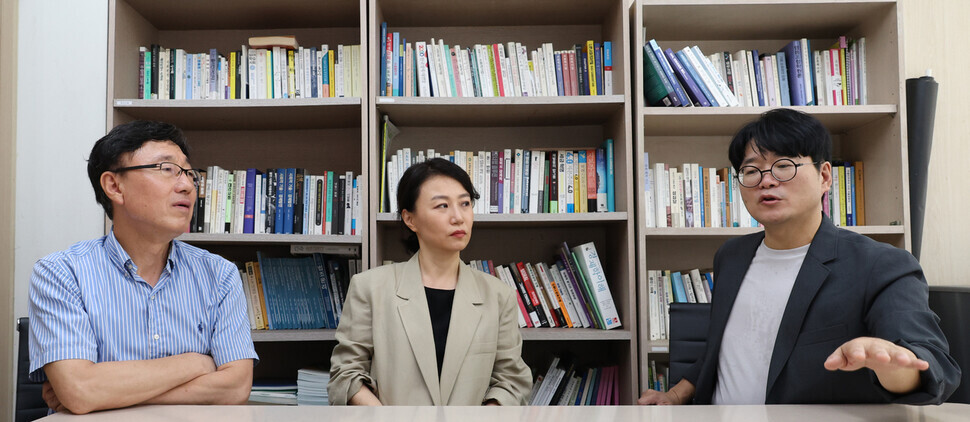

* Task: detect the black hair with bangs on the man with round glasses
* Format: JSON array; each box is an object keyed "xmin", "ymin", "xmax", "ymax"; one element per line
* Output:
[{"xmin": 728, "ymin": 108, "xmax": 832, "ymax": 170}]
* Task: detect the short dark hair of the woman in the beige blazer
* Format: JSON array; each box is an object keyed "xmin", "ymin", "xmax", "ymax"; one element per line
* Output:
[{"xmin": 397, "ymin": 158, "xmax": 480, "ymax": 253}]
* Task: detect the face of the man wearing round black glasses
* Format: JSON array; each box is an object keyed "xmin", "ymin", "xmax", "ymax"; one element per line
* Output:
[{"xmin": 740, "ymin": 142, "xmax": 832, "ymax": 228}]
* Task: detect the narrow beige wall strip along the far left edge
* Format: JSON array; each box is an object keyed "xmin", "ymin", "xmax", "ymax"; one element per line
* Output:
[{"xmin": 0, "ymin": 0, "xmax": 17, "ymax": 421}]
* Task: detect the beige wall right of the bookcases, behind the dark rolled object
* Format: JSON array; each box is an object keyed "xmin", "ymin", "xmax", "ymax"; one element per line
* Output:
[{"xmin": 901, "ymin": 0, "xmax": 970, "ymax": 285}]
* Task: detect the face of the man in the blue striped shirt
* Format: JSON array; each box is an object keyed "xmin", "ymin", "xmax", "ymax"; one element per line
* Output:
[{"xmin": 113, "ymin": 141, "xmax": 197, "ymax": 239}]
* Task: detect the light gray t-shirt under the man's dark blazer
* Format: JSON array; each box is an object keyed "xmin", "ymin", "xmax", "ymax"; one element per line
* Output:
[{"xmin": 714, "ymin": 241, "xmax": 811, "ymax": 404}]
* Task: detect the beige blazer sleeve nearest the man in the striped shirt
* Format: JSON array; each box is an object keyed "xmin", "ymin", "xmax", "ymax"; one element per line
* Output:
[{"xmin": 327, "ymin": 275, "xmax": 377, "ymax": 405}]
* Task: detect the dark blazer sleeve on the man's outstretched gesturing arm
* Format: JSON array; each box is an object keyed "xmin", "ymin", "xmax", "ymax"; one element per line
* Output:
[{"xmin": 866, "ymin": 248, "xmax": 961, "ymax": 404}]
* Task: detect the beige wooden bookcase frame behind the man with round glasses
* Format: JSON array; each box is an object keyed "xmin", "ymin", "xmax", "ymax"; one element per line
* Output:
[{"xmin": 629, "ymin": 0, "xmax": 911, "ymax": 389}]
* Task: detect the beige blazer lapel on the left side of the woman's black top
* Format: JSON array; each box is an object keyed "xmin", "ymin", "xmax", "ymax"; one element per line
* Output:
[{"xmin": 396, "ymin": 254, "xmax": 440, "ymax": 406}]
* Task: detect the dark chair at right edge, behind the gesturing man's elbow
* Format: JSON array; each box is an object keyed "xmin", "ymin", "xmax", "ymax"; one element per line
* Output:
[{"xmin": 930, "ymin": 286, "xmax": 970, "ymax": 404}]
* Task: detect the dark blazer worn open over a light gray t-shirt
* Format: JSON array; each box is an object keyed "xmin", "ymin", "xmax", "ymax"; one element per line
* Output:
[{"xmin": 684, "ymin": 218, "xmax": 960, "ymax": 404}]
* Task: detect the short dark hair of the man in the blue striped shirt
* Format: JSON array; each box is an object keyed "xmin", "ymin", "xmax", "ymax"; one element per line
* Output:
[{"xmin": 88, "ymin": 120, "xmax": 189, "ymax": 219}]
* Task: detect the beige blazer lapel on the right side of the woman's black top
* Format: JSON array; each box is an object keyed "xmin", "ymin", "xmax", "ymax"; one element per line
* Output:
[{"xmin": 440, "ymin": 263, "xmax": 482, "ymax": 404}]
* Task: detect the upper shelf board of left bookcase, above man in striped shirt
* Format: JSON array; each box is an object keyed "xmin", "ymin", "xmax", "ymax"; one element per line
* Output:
[{"xmin": 114, "ymin": 97, "xmax": 362, "ymax": 130}]
